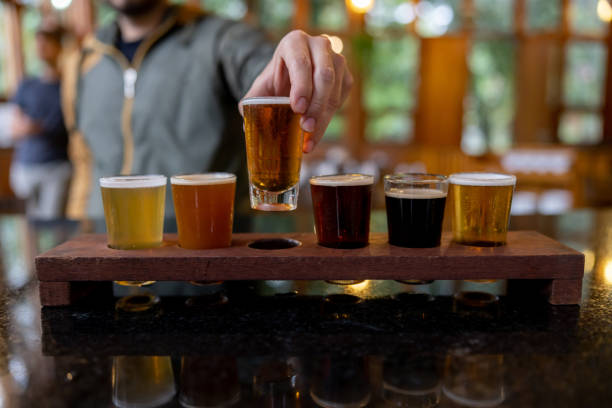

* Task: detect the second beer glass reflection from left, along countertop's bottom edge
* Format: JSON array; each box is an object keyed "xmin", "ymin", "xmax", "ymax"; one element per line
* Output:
[{"xmin": 179, "ymin": 356, "xmax": 240, "ymax": 408}]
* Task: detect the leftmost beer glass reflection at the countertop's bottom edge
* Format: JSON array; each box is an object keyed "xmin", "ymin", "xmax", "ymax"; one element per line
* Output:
[{"xmin": 112, "ymin": 356, "xmax": 176, "ymax": 408}]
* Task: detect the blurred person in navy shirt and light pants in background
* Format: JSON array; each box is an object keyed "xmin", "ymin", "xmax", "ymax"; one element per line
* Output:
[{"xmin": 10, "ymin": 22, "xmax": 71, "ymax": 219}]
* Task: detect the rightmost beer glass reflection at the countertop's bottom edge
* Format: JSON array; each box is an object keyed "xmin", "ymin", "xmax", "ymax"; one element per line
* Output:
[{"xmin": 442, "ymin": 352, "xmax": 505, "ymax": 408}]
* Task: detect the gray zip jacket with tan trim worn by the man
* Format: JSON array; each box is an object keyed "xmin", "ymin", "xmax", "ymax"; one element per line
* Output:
[{"xmin": 63, "ymin": 6, "xmax": 274, "ymax": 218}]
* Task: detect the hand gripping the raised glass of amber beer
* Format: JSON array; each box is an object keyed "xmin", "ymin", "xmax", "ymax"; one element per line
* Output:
[{"xmin": 245, "ymin": 30, "xmax": 353, "ymax": 153}]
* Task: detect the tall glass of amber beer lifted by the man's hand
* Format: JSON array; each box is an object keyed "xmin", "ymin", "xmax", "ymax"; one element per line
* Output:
[{"xmin": 240, "ymin": 97, "xmax": 304, "ymax": 211}]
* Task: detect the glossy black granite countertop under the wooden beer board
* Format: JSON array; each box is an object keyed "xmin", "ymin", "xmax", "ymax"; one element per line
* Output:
[{"xmin": 0, "ymin": 210, "xmax": 612, "ymax": 408}]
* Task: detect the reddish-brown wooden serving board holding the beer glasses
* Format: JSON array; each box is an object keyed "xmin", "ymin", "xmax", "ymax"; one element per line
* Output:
[{"xmin": 36, "ymin": 231, "xmax": 584, "ymax": 305}]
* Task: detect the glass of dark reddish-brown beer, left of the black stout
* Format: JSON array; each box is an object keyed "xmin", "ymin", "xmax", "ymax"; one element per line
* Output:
[{"xmin": 310, "ymin": 174, "xmax": 374, "ymax": 248}]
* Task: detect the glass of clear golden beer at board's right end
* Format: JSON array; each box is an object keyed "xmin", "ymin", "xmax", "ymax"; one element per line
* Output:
[{"xmin": 449, "ymin": 173, "xmax": 516, "ymax": 246}]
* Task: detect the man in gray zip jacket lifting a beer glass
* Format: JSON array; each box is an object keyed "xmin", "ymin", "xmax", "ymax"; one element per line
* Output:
[{"xmin": 64, "ymin": 0, "xmax": 352, "ymax": 217}]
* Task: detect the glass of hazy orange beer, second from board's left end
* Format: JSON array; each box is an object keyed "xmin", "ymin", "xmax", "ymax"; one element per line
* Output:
[{"xmin": 170, "ymin": 173, "xmax": 236, "ymax": 249}]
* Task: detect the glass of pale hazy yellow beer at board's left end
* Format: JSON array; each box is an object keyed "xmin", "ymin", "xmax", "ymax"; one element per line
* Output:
[{"xmin": 100, "ymin": 175, "xmax": 166, "ymax": 249}]
